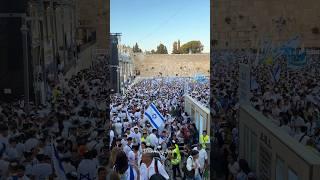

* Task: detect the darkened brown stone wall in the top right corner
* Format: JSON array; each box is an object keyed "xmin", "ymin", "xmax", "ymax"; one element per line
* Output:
[{"xmin": 211, "ymin": 0, "xmax": 320, "ymax": 49}]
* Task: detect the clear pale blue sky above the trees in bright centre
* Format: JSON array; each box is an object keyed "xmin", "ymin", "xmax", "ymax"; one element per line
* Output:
[{"xmin": 110, "ymin": 0, "xmax": 210, "ymax": 53}]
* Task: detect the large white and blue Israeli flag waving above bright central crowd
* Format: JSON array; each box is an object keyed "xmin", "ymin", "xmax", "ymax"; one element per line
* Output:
[{"xmin": 144, "ymin": 103, "xmax": 164, "ymax": 129}]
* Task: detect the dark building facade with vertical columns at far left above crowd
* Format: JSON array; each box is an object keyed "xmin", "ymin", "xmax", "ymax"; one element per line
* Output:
[{"xmin": 0, "ymin": 0, "xmax": 76, "ymax": 103}]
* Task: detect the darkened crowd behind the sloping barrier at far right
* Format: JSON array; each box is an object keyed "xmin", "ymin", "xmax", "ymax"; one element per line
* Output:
[{"xmin": 251, "ymin": 56, "xmax": 320, "ymax": 153}]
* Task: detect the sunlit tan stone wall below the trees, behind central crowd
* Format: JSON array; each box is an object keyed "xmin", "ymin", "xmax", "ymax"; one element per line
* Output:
[{"xmin": 133, "ymin": 54, "xmax": 210, "ymax": 77}]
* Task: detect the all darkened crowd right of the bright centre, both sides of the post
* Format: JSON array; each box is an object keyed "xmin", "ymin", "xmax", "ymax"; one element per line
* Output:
[{"xmin": 210, "ymin": 51, "xmax": 320, "ymax": 179}]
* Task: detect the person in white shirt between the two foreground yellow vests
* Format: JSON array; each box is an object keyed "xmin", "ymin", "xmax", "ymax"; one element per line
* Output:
[{"xmin": 186, "ymin": 150, "xmax": 201, "ymax": 180}]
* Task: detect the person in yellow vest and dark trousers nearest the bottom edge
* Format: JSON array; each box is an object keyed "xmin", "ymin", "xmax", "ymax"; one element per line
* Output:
[{"xmin": 171, "ymin": 141, "xmax": 181, "ymax": 179}]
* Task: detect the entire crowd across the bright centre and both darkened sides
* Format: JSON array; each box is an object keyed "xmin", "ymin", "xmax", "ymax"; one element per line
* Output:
[{"xmin": 4, "ymin": 46, "xmax": 320, "ymax": 180}]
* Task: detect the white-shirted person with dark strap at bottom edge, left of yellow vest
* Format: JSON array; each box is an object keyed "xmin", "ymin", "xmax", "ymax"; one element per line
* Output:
[{"xmin": 140, "ymin": 152, "xmax": 169, "ymax": 180}]
